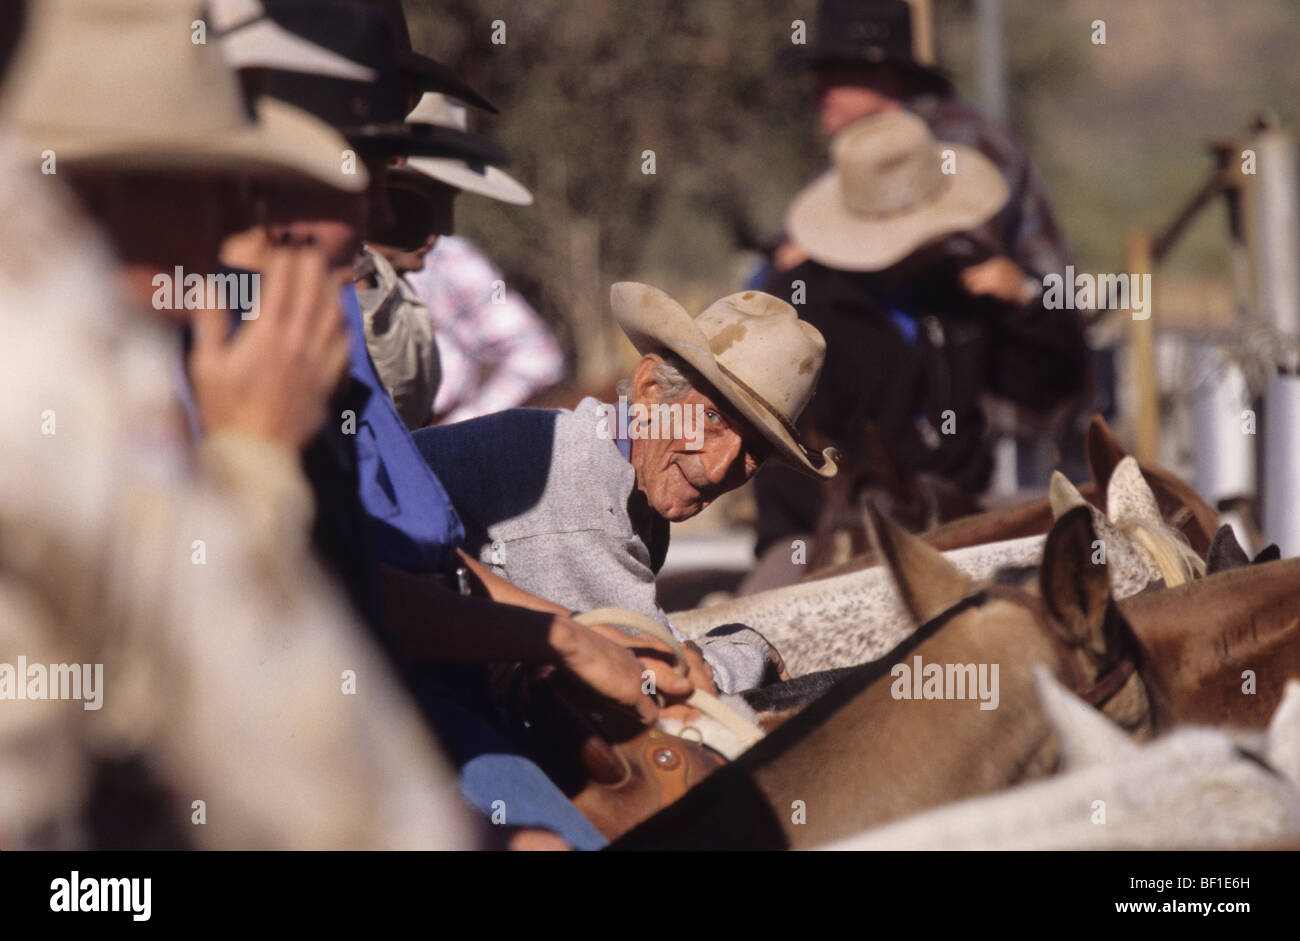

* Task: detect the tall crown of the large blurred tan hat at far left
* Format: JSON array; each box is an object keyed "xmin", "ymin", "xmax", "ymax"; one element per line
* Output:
[{"xmin": 0, "ymin": 0, "xmax": 252, "ymax": 146}]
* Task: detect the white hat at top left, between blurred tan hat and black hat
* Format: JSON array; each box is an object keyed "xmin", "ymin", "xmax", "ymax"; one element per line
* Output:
[{"xmin": 208, "ymin": 0, "xmax": 374, "ymax": 82}]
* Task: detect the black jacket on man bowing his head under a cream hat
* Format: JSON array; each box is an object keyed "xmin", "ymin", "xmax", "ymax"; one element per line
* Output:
[{"xmin": 757, "ymin": 261, "xmax": 1087, "ymax": 551}]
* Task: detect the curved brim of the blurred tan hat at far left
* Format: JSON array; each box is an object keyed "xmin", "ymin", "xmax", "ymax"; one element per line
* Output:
[{"xmin": 39, "ymin": 97, "xmax": 371, "ymax": 194}]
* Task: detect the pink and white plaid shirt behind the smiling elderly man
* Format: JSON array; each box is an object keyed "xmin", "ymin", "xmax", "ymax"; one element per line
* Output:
[{"xmin": 407, "ymin": 235, "xmax": 564, "ymax": 425}]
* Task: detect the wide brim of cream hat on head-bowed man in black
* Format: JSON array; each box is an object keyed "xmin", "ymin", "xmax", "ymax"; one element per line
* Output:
[{"xmin": 785, "ymin": 143, "xmax": 1010, "ymax": 272}]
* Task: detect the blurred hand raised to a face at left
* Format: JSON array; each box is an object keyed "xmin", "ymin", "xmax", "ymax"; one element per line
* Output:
[{"xmin": 190, "ymin": 240, "xmax": 348, "ymax": 451}]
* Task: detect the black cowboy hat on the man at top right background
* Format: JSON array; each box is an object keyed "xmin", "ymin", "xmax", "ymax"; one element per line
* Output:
[{"xmin": 777, "ymin": 0, "xmax": 953, "ymax": 95}]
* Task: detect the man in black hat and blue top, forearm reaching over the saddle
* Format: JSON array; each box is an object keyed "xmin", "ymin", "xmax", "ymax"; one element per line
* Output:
[{"xmin": 215, "ymin": 0, "xmax": 692, "ymax": 849}]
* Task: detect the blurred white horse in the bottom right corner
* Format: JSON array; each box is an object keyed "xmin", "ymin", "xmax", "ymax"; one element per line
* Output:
[{"xmin": 823, "ymin": 669, "xmax": 1300, "ymax": 850}]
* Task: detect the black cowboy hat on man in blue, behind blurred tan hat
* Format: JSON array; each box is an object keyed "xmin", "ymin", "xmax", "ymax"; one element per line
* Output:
[{"xmin": 267, "ymin": 0, "xmax": 510, "ymax": 166}]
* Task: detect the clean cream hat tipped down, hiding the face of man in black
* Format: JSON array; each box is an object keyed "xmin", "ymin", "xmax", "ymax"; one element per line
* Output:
[{"xmin": 785, "ymin": 110, "xmax": 1010, "ymax": 272}]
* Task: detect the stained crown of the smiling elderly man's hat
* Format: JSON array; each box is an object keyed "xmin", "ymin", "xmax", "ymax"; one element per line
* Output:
[{"xmin": 696, "ymin": 291, "xmax": 826, "ymax": 425}]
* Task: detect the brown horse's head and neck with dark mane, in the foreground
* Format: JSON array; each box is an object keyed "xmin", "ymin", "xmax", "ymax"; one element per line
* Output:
[{"xmin": 615, "ymin": 507, "xmax": 1151, "ymax": 849}]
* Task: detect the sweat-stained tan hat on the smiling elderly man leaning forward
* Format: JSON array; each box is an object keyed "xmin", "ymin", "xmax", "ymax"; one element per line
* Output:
[{"xmin": 610, "ymin": 281, "xmax": 837, "ymax": 477}]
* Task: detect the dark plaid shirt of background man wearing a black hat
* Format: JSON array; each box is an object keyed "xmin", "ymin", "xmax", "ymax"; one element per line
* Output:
[{"xmin": 906, "ymin": 95, "xmax": 1070, "ymax": 279}]
